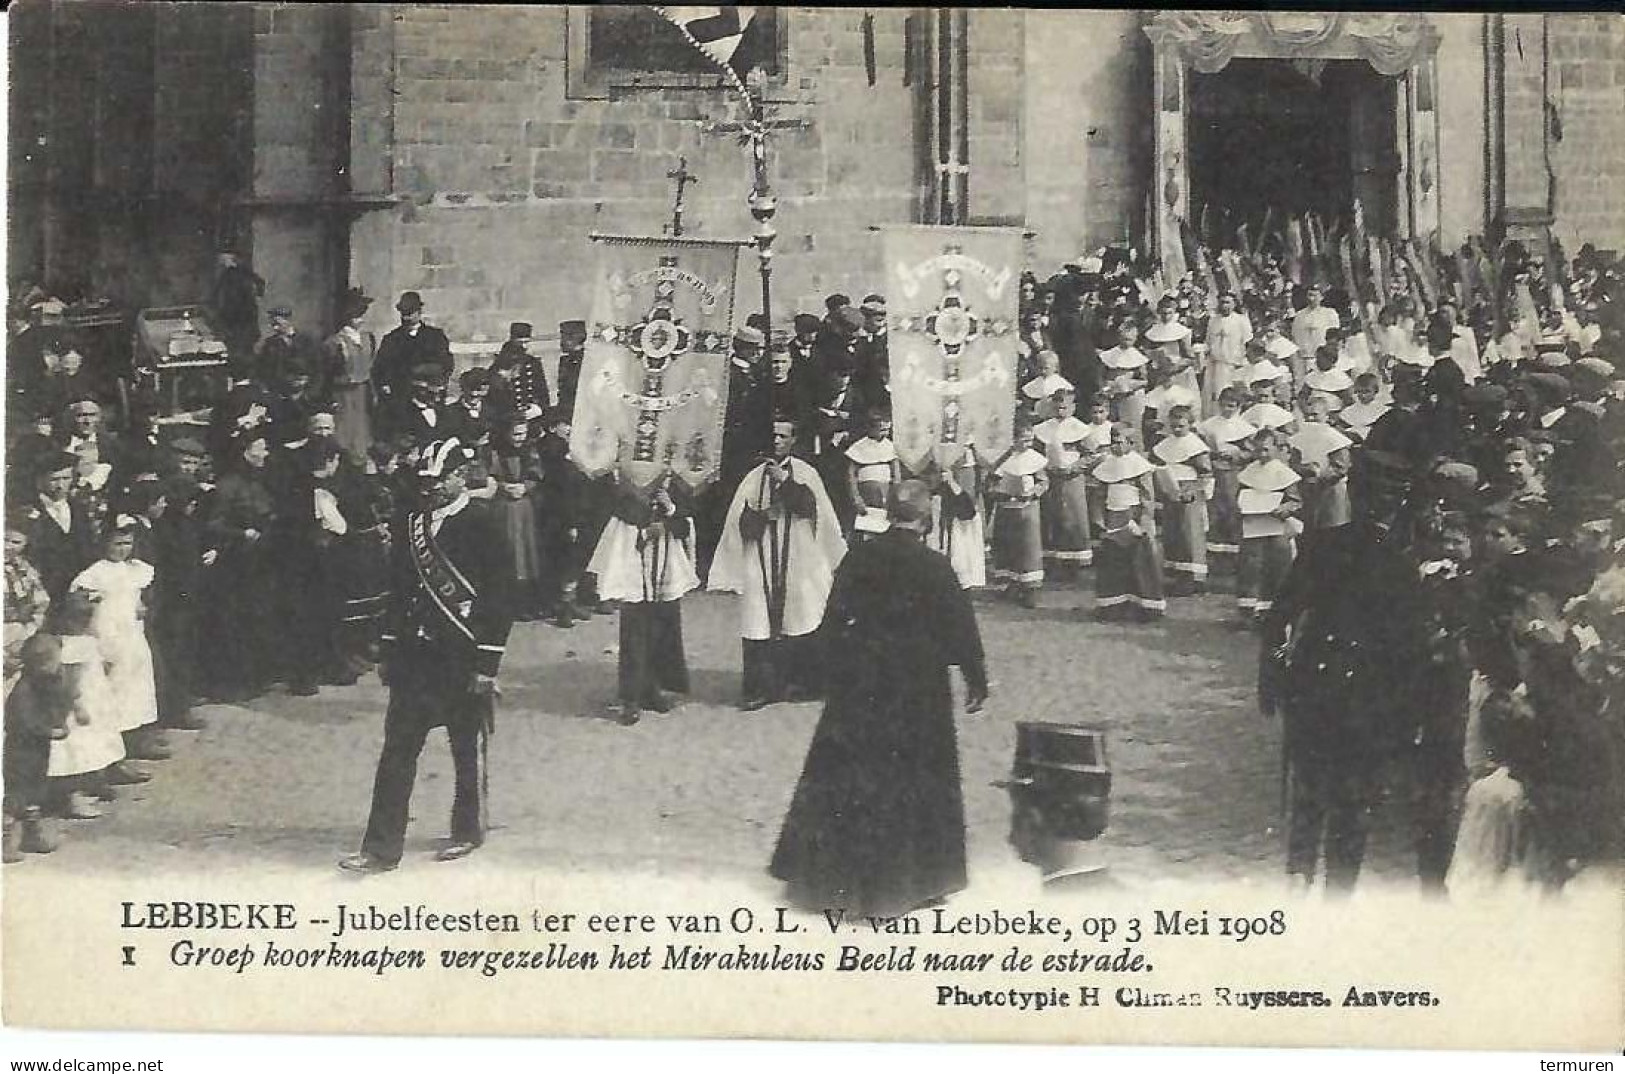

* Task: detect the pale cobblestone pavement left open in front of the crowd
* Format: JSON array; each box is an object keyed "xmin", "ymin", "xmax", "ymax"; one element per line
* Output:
[{"xmin": 12, "ymin": 578, "xmax": 1436, "ymax": 886}]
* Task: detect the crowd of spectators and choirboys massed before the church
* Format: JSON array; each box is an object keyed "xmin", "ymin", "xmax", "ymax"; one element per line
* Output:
[{"xmin": 5, "ymin": 230, "xmax": 1625, "ymax": 886}]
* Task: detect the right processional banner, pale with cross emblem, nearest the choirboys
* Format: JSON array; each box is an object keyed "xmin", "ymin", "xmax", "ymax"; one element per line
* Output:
[{"xmin": 881, "ymin": 226, "xmax": 1022, "ymax": 473}]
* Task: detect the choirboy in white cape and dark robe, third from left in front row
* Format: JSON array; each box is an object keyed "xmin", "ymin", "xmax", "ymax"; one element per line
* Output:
[{"xmin": 1095, "ymin": 421, "xmax": 1168, "ymax": 622}]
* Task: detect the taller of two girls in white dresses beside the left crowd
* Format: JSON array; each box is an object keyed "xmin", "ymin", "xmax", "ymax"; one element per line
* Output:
[{"xmin": 73, "ymin": 515, "xmax": 158, "ymax": 757}]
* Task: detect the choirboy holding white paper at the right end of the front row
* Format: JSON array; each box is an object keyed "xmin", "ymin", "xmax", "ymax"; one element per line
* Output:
[{"xmin": 1237, "ymin": 429, "xmax": 1302, "ymax": 622}]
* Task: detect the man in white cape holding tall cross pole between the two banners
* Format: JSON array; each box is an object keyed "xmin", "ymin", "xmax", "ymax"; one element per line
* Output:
[{"xmin": 709, "ymin": 421, "xmax": 847, "ymax": 712}]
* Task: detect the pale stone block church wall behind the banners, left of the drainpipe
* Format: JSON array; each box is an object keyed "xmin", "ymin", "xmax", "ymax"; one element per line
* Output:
[{"xmin": 353, "ymin": 5, "xmax": 917, "ymax": 341}]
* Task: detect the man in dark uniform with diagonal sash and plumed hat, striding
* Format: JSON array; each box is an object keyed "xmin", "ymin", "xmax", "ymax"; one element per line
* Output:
[{"xmin": 338, "ymin": 439, "xmax": 514, "ymax": 873}]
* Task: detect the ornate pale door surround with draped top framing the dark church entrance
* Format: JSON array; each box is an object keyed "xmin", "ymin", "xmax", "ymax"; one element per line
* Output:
[{"xmin": 1146, "ymin": 11, "xmax": 1441, "ymax": 268}]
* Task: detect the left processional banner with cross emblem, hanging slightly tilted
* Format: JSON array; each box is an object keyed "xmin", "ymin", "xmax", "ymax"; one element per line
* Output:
[{"xmin": 570, "ymin": 236, "xmax": 743, "ymax": 489}]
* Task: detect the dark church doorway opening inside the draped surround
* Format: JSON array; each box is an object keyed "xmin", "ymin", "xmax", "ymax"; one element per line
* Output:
[{"xmin": 1186, "ymin": 58, "xmax": 1401, "ymax": 242}]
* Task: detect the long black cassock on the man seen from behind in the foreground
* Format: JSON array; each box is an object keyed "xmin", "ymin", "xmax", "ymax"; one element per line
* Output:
[{"xmin": 769, "ymin": 530, "xmax": 986, "ymax": 913}]
